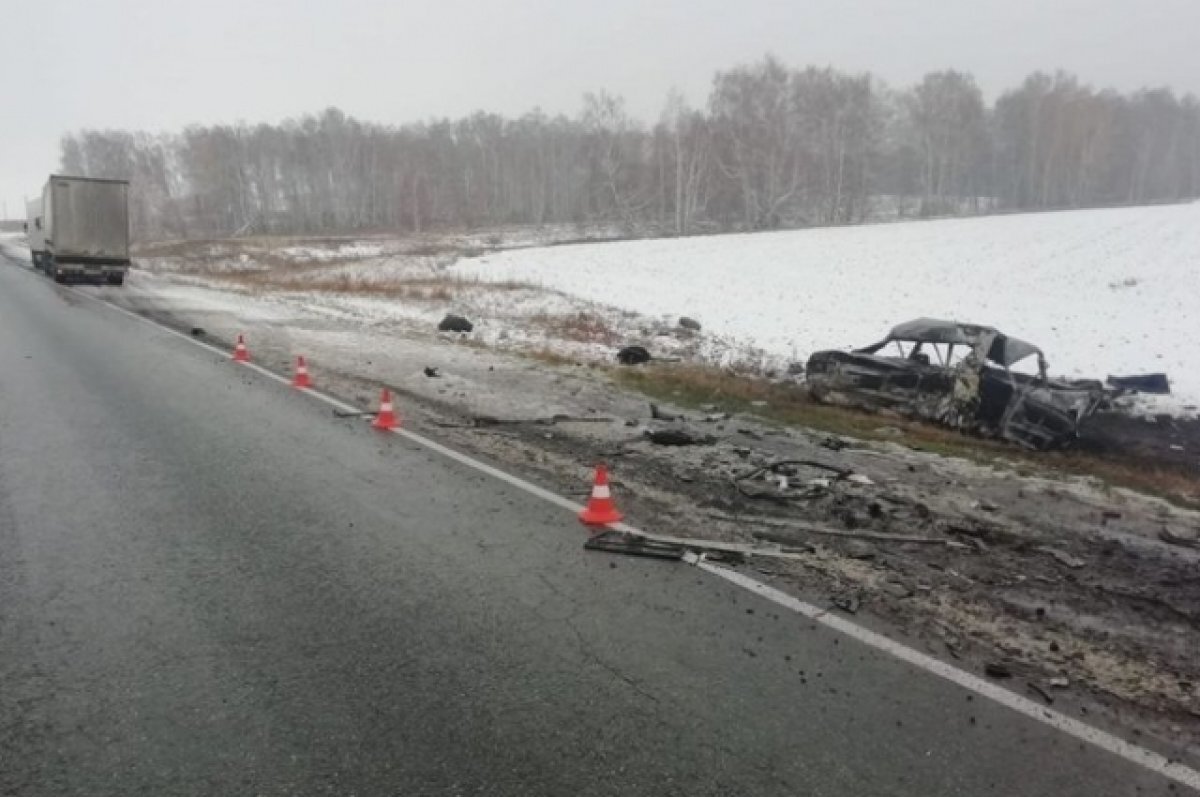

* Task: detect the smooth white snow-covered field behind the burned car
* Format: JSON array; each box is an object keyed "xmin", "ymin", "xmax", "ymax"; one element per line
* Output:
[{"xmin": 454, "ymin": 203, "xmax": 1200, "ymax": 409}]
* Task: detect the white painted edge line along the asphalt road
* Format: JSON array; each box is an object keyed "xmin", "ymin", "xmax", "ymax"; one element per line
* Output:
[{"xmin": 49, "ymin": 273, "xmax": 1200, "ymax": 791}]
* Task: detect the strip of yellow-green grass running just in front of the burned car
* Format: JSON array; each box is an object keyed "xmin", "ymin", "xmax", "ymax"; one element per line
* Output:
[{"xmin": 610, "ymin": 365, "xmax": 1200, "ymax": 510}]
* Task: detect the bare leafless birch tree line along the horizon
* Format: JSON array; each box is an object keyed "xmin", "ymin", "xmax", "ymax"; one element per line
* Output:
[{"xmin": 61, "ymin": 56, "xmax": 1200, "ymax": 238}]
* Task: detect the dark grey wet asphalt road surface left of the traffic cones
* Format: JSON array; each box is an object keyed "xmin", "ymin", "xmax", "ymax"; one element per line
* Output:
[{"xmin": 0, "ymin": 252, "xmax": 1184, "ymax": 797}]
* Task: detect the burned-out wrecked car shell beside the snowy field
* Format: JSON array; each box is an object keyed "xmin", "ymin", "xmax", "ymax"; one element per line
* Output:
[{"xmin": 806, "ymin": 318, "xmax": 1105, "ymax": 449}]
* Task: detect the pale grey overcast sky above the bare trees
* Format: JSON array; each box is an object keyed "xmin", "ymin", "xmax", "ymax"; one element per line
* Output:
[{"xmin": 0, "ymin": 0, "xmax": 1200, "ymax": 216}]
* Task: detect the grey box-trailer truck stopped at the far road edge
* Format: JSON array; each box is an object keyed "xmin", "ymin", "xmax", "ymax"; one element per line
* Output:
[{"xmin": 25, "ymin": 174, "xmax": 130, "ymax": 284}]
